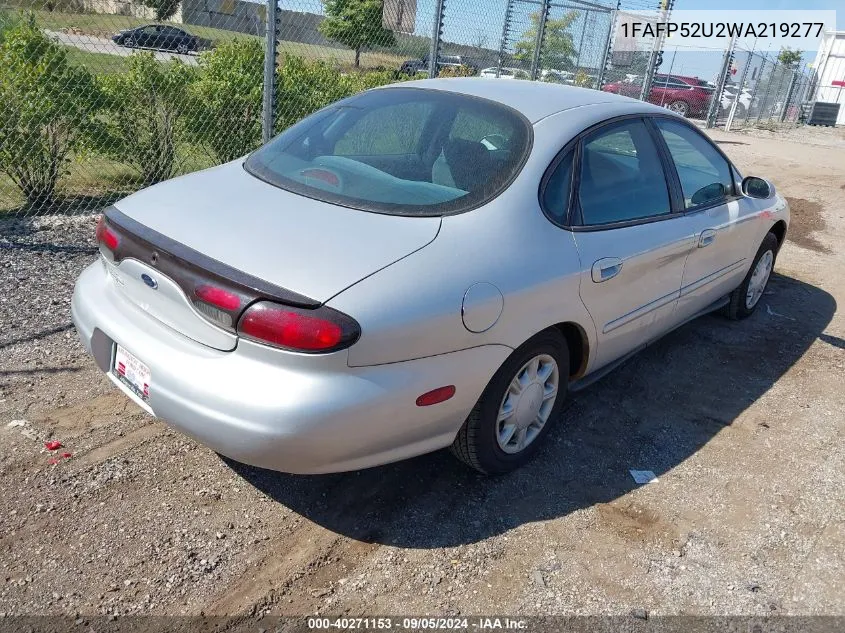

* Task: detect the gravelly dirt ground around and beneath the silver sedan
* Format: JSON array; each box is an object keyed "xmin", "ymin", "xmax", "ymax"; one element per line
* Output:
[{"xmin": 0, "ymin": 124, "xmax": 845, "ymax": 616}]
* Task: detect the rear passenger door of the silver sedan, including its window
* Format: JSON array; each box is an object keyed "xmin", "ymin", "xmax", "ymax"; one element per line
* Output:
[{"xmin": 572, "ymin": 118, "xmax": 693, "ymax": 369}]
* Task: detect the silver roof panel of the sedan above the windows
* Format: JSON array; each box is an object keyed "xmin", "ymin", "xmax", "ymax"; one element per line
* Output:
[{"xmin": 379, "ymin": 77, "xmax": 665, "ymax": 123}]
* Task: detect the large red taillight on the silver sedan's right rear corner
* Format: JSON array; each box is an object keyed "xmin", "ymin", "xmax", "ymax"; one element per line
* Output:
[{"xmin": 238, "ymin": 301, "xmax": 361, "ymax": 353}]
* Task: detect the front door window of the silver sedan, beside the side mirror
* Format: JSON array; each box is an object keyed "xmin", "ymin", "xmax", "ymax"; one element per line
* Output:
[{"xmin": 655, "ymin": 119, "xmax": 733, "ymax": 209}]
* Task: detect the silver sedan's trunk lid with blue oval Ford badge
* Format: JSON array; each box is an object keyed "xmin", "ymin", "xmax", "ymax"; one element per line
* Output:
[{"xmin": 101, "ymin": 162, "xmax": 440, "ymax": 349}]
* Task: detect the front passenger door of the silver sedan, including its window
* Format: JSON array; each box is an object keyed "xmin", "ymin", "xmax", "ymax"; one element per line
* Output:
[{"xmin": 653, "ymin": 117, "xmax": 758, "ymax": 319}]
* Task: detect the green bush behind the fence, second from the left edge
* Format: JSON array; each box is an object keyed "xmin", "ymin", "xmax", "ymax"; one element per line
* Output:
[{"xmin": 99, "ymin": 53, "xmax": 194, "ymax": 185}]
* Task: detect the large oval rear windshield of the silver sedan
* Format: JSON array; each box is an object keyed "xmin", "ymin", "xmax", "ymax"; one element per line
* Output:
[{"xmin": 245, "ymin": 88, "xmax": 531, "ymax": 215}]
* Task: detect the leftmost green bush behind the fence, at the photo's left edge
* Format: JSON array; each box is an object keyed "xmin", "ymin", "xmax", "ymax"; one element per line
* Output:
[{"xmin": 0, "ymin": 16, "xmax": 98, "ymax": 209}]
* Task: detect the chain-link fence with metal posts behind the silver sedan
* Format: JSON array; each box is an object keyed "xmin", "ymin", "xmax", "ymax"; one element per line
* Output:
[{"xmin": 0, "ymin": 0, "xmax": 832, "ymax": 222}]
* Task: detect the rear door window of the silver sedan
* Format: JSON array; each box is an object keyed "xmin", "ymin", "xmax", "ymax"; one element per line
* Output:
[{"xmin": 578, "ymin": 120, "xmax": 672, "ymax": 226}]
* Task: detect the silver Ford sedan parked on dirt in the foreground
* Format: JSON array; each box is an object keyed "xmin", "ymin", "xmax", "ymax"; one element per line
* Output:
[{"xmin": 72, "ymin": 78, "xmax": 789, "ymax": 473}]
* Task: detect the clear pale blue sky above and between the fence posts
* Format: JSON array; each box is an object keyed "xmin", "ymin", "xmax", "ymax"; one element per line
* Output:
[{"xmin": 276, "ymin": 0, "xmax": 845, "ymax": 81}]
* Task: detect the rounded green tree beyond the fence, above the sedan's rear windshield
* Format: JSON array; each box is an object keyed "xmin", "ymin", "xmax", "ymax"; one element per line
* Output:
[{"xmin": 319, "ymin": 0, "xmax": 396, "ymax": 68}]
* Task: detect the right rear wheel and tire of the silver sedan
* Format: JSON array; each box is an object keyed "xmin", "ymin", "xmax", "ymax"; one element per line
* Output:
[{"xmin": 451, "ymin": 330, "xmax": 569, "ymax": 474}]
